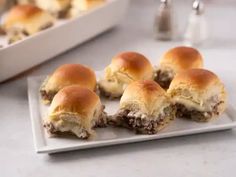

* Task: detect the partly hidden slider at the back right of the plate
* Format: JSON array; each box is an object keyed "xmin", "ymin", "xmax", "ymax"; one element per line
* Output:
[{"xmin": 154, "ymin": 47, "xmax": 203, "ymax": 89}]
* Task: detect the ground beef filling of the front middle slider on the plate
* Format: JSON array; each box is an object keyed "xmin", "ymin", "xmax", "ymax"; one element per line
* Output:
[{"xmin": 109, "ymin": 105, "xmax": 176, "ymax": 134}]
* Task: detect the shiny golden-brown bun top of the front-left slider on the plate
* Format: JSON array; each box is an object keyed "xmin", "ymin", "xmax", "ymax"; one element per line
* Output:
[{"xmin": 50, "ymin": 85, "xmax": 101, "ymax": 118}]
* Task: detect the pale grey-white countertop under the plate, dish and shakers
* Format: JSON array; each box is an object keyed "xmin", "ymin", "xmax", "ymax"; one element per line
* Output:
[{"xmin": 0, "ymin": 0, "xmax": 236, "ymax": 177}]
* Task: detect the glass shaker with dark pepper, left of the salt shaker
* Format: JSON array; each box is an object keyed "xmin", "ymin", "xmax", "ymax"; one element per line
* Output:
[{"xmin": 154, "ymin": 0, "xmax": 174, "ymax": 40}]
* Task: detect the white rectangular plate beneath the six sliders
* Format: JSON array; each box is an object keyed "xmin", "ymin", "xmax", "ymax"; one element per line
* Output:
[{"xmin": 28, "ymin": 72, "xmax": 236, "ymax": 153}]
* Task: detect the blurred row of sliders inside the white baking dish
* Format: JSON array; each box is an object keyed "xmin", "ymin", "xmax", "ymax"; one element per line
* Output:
[{"xmin": 0, "ymin": 0, "xmax": 106, "ymax": 44}]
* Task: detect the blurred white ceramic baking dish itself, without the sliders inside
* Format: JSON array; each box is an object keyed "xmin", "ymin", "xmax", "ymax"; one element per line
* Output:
[{"xmin": 0, "ymin": 0, "xmax": 129, "ymax": 82}]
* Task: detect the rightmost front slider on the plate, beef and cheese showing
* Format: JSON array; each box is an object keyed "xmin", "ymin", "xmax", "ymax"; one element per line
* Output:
[{"xmin": 167, "ymin": 69, "xmax": 226, "ymax": 122}]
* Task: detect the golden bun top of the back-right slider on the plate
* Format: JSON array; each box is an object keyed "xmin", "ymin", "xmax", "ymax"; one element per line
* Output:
[{"xmin": 160, "ymin": 46, "xmax": 203, "ymax": 72}]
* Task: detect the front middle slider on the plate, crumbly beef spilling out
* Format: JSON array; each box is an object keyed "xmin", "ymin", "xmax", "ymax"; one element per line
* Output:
[{"xmin": 109, "ymin": 80, "xmax": 176, "ymax": 134}]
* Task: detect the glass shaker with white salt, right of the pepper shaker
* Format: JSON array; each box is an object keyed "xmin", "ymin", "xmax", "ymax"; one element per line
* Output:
[{"xmin": 184, "ymin": 0, "xmax": 208, "ymax": 46}]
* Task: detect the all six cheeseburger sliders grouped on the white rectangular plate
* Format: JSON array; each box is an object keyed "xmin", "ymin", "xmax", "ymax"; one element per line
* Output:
[{"xmin": 40, "ymin": 47, "xmax": 226, "ymax": 139}]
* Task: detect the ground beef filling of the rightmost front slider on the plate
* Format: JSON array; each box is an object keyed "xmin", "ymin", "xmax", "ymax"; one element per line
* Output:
[{"xmin": 176, "ymin": 101, "xmax": 224, "ymax": 122}]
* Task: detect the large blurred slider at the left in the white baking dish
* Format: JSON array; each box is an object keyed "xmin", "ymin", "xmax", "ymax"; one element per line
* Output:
[{"xmin": 3, "ymin": 4, "xmax": 55, "ymax": 41}]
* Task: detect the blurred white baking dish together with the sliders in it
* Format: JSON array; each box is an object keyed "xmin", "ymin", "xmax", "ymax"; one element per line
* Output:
[{"xmin": 0, "ymin": 0, "xmax": 129, "ymax": 82}]
